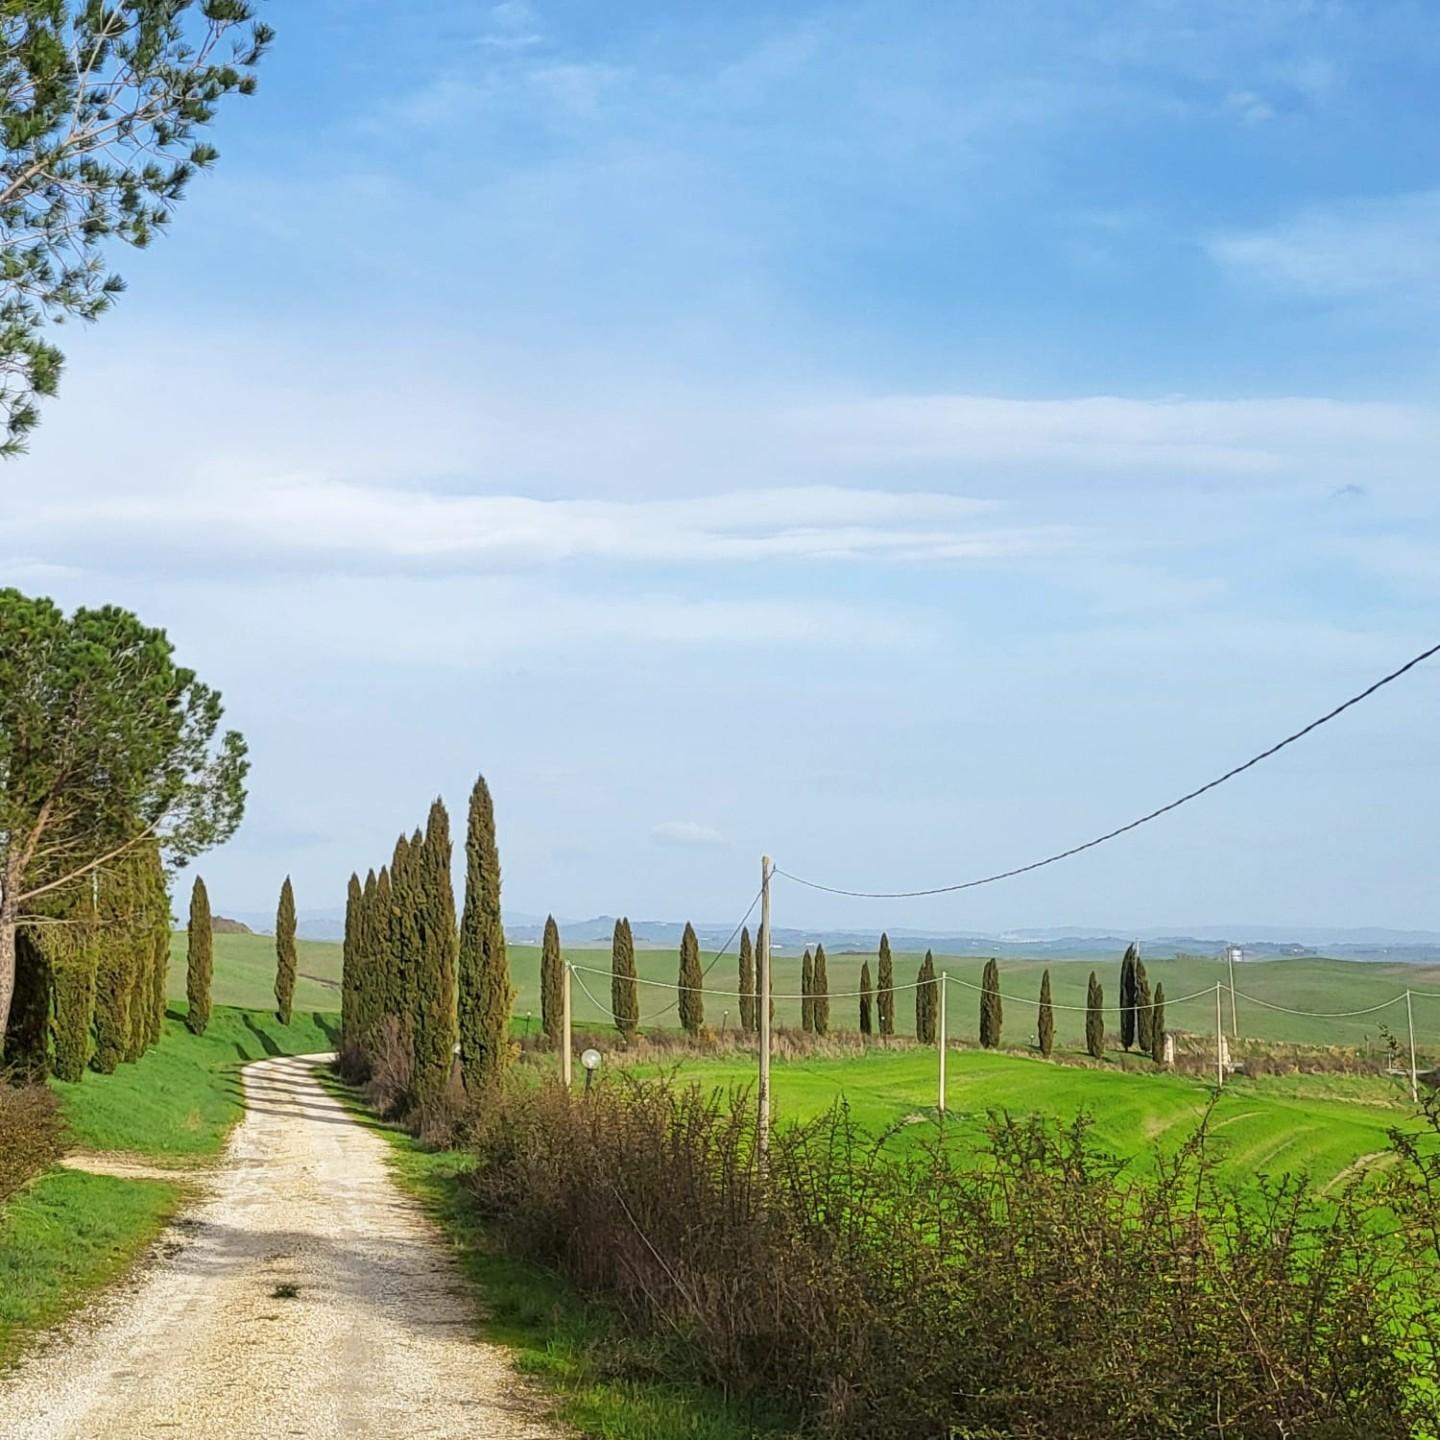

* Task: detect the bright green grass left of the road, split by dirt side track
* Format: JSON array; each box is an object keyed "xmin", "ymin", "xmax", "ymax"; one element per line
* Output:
[{"xmin": 0, "ymin": 1007, "xmax": 336, "ymax": 1365}]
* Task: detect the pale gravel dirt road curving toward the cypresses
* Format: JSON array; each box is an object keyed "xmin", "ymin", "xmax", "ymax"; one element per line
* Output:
[{"xmin": 0, "ymin": 1058, "xmax": 557, "ymax": 1440}]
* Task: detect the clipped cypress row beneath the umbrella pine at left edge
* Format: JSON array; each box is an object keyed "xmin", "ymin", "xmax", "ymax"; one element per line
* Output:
[{"xmin": 4, "ymin": 841, "xmax": 170, "ymax": 1081}]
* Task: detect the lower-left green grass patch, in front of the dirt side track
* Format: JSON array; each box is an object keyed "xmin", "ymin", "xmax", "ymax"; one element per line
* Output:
[{"xmin": 0, "ymin": 1169, "xmax": 184, "ymax": 1367}]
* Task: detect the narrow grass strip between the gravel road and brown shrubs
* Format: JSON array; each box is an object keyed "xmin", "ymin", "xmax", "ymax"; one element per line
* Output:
[{"xmin": 323, "ymin": 1077, "xmax": 785, "ymax": 1440}]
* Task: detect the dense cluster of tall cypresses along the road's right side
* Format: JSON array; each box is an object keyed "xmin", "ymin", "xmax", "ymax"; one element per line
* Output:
[{"xmin": 340, "ymin": 776, "xmax": 512, "ymax": 1107}]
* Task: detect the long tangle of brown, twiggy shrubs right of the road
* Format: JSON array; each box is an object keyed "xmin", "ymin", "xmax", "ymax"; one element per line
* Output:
[{"xmin": 467, "ymin": 1077, "xmax": 1440, "ymax": 1440}]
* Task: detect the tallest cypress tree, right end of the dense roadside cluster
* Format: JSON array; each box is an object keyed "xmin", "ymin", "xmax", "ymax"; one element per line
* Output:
[{"xmin": 459, "ymin": 775, "xmax": 516, "ymax": 1094}]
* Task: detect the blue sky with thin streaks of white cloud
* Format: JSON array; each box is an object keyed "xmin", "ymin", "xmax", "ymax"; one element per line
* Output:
[{"xmin": 8, "ymin": 0, "xmax": 1440, "ymax": 929}]
